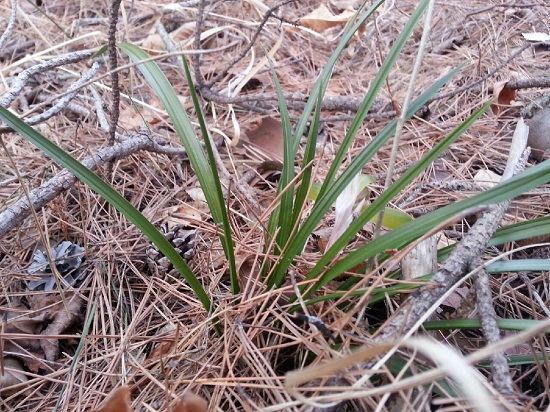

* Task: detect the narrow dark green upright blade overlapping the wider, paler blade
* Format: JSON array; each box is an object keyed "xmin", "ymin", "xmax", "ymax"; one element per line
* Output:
[{"xmin": 182, "ymin": 56, "xmax": 240, "ymax": 295}]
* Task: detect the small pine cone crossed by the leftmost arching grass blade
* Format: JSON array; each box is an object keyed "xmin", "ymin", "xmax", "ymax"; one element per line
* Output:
[{"xmin": 145, "ymin": 223, "xmax": 197, "ymax": 275}]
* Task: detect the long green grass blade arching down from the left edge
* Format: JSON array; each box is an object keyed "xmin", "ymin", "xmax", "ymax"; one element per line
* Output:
[{"xmin": 0, "ymin": 107, "xmax": 212, "ymax": 312}]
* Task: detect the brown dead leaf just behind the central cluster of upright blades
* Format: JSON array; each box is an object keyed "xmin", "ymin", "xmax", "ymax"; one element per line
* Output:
[{"xmin": 243, "ymin": 117, "xmax": 284, "ymax": 163}]
